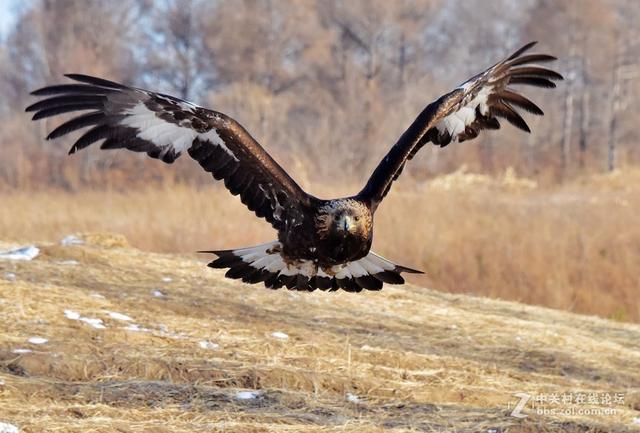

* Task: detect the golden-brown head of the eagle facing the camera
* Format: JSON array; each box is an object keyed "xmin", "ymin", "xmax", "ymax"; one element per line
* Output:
[{"xmin": 316, "ymin": 199, "xmax": 372, "ymax": 238}]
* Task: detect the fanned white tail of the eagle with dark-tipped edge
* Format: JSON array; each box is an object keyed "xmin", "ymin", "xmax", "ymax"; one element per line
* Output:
[{"xmin": 198, "ymin": 241, "xmax": 422, "ymax": 292}]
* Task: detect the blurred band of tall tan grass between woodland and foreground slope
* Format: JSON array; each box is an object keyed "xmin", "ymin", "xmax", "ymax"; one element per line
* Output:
[{"xmin": 0, "ymin": 165, "xmax": 640, "ymax": 321}]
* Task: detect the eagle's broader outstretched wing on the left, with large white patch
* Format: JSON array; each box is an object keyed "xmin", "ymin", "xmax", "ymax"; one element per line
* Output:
[{"xmin": 26, "ymin": 74, "xmax": 312, "ymax": 229}]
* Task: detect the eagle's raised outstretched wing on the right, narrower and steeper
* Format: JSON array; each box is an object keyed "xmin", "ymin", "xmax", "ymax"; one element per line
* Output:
[{"xmin": 359, "ymin": 42, "xmax": 562, "ymax": 209}]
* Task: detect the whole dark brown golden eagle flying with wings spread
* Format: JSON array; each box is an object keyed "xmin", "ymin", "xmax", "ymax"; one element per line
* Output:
[{"xmin": 26, "ymin": 42, "xmax": 562, "ymax": 292}]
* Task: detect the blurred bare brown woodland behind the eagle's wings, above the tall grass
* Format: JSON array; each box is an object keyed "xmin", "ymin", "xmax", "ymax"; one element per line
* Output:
[{"xmin": 0, "ymin": 0, "xmax": 640, "ymax": 189}]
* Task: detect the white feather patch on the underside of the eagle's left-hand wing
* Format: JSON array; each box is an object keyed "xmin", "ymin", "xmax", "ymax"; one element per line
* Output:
[{"xmin": 121, "ymin": 102, "xmax": 238, "ymax": 161}]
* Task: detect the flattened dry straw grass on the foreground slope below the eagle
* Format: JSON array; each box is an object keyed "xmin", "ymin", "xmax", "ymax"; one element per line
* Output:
[{"xmin": 0, "ymin": 235, "xmax": 640, "ymax": 433}]
